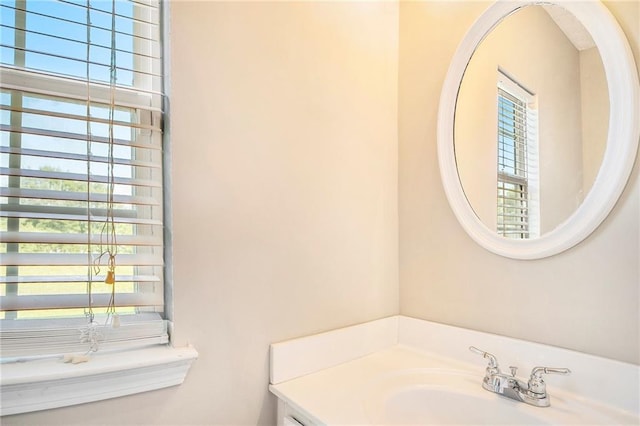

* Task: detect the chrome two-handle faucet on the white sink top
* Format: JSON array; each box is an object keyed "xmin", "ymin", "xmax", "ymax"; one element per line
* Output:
[{"xmin": 469, "ymin": 346, "xmax": 571, "ymax": 407}]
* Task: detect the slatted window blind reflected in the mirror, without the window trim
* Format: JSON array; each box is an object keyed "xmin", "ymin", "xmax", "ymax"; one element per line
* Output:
[{"xmin": 497, "ymin": 88, "xmax": 529, "ymax": 239}]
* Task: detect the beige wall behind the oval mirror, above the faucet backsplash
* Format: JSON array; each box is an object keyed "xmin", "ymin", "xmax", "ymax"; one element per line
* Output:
[{"xmin": 399, "ymin": 2, "xmax": 640, "ymax": 363}]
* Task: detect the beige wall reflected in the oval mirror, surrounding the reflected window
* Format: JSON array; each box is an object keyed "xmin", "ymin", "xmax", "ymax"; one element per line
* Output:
[{"xmin": 455, "ymin": 6, "xmax": 592, "ymax": 234}]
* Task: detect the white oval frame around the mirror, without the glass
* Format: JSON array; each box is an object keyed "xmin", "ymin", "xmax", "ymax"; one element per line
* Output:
[{"xmin": 438, "ymin": 0, "xmax": 640, "ymax": 259}]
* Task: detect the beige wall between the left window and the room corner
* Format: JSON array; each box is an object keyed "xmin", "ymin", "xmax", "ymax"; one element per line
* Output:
[{"xmin": 2, "ymin": 1, "xmax": 398, "ymax": 425}]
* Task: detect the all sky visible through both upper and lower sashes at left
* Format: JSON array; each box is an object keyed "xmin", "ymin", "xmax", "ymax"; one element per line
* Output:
[{"xmin": 0, "ymin": 0, "xmax": 135, "ymax": 188}]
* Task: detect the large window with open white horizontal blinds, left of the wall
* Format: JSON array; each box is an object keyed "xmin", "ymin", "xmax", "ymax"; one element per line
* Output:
[{"xmin": 0, "ymin": 0, "xmax": 166, "ymax": 343}]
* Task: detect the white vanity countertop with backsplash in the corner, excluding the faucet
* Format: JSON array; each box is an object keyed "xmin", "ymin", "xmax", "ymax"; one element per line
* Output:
[{"xmin": 269, "ymin": 317, "xmax": 640, "ymax": 425}]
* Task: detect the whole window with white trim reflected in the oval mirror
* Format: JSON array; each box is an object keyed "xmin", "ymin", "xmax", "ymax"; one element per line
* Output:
[{"xmin": 497, "ymin": 73, "xmax": 539, "ymax": 239}]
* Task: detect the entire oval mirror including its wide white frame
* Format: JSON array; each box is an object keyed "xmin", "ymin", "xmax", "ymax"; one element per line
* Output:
[{"xmin": 438, "ymin": 1, "xmax": 640, "ymax": 259}]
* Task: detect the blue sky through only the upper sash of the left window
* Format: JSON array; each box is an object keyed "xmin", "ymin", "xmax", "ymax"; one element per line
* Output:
[{"xmin": 0, "ymin": 0, "xmax": 134, "ymax": 86}]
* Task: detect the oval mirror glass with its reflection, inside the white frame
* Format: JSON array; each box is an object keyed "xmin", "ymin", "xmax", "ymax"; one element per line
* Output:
[{"xmin": 454, "ymin": 5, "xmax": 609, "ymax": 239}]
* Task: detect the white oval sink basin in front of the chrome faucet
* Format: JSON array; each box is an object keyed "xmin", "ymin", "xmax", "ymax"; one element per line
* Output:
[{"xmin": 363, "ymin": 369, "xmax": 637, "ymax": 425}]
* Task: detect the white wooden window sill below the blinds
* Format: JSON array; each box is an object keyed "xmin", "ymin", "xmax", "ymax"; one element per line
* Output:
[{"xmin": 0, "ymin": 346, "xmax": 198, "ymax": 416}]
